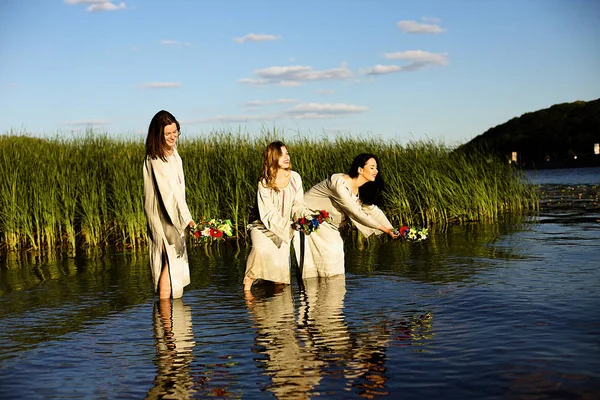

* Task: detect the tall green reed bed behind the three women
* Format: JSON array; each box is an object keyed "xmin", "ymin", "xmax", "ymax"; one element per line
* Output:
[{"xmin": 0, "ymin": 131, "xmax": 538, "ymax": 251}]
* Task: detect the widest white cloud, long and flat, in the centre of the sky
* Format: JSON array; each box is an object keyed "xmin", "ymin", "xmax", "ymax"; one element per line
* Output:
[{"xmin": 239, "ymin": 63, "xmax": 352, "ymax": 86}]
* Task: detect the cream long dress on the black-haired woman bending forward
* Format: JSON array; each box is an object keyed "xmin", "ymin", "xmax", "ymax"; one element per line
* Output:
[{"xmin": 294, "ymin": 173, "xmax": 393, "ymax": 278}]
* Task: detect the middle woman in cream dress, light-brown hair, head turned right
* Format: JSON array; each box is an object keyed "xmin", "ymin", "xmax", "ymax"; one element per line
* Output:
[{"xmin": 244, "ymin": 141, "xmax": 312, "ymax": 291}]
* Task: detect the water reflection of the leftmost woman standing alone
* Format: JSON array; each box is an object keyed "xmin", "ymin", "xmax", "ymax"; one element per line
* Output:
[{"xmin": 146, "ymin": 299, "xmax": 196, "ymax": 399}]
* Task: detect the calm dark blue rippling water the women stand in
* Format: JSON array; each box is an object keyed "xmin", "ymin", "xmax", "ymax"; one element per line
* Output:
[{"xmin": 0, "ymin": 169, "xmax": 600, "ymax": 399}]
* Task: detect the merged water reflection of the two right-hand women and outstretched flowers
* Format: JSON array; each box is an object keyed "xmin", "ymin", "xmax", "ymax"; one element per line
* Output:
[{"xmin": 246, "ymin": 275, "xmax": 433, "ymax": 398}]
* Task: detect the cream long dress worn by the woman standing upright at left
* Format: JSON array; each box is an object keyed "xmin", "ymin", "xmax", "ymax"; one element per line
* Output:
[{"xmin": 144, "ymin": 149, "xmax": 193, "ymax": 299}]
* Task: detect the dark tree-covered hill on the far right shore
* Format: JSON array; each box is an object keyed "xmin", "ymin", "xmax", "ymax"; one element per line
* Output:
[{"xmin": 457, "ymin": 99, "xmax": 600, "ymax": 168}]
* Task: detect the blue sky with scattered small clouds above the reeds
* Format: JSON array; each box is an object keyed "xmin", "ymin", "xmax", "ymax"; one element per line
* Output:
[{"xmin": 0, "ymin": 0, "xmax": 600, "ymax": 145}]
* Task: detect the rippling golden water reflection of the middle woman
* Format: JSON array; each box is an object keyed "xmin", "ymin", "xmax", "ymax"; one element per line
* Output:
[{"xmin": 247, "ymin": 286, "xmax": 323, "ymax": 399}]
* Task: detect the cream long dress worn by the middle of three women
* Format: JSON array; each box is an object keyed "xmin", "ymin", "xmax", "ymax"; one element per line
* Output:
[{"xmin": 244, "ymin": 171, "xmax": 311, "ymax": 284}]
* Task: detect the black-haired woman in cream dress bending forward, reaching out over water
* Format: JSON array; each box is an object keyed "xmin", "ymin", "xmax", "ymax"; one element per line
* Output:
[{"xmin": 294, "ymin": 153, "xmax": 398, "ymax": 278}]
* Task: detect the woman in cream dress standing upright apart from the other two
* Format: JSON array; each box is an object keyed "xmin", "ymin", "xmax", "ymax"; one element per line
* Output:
[{"xmin": 144, "ymin": 110, "xmax": 196, "ymax": 299}]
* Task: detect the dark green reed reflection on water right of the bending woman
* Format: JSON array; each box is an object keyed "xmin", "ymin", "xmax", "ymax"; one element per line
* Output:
[{"xmin": 345, "ymin": 222, "xmax": 532, "ymax": 284}]
